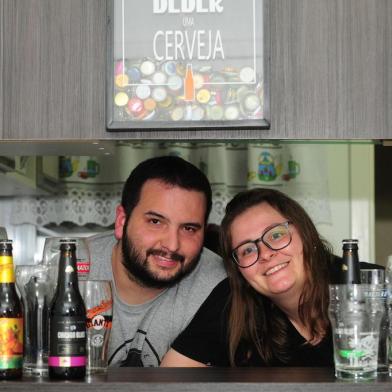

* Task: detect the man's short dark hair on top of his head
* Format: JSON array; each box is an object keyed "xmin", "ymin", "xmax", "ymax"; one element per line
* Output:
[{"xmin": 121, "ymin": 156, "xmax": 212, "ymax": 222}]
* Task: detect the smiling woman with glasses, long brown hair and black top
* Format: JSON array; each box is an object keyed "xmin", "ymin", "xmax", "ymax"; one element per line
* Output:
[{"xmin": 162, "ymin": 189, "xmax": 333, "ymax": 366}]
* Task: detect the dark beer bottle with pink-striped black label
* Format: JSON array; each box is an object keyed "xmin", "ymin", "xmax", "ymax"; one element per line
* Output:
[{"xmin": 48, "ymin": 239, "xmax": 87, "ymax": 380}]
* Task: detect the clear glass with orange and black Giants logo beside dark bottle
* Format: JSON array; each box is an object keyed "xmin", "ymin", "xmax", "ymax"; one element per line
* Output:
[{"xmin": 79, "ymin": 280, "xmax": 113, "ymax": 375}]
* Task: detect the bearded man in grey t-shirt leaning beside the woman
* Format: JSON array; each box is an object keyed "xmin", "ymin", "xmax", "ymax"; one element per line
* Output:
[{"xmin": 89, "ymin": 156, "xmax": 226, "ymax": 366}]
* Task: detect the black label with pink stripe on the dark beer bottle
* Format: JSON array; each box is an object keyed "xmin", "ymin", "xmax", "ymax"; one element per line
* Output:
[{"xmin": 48, "ymin": 316, "xmax": 87, "ymax": 367}]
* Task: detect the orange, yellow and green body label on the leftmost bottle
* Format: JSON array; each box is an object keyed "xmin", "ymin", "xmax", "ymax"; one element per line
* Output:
[{"xmin": 0, "ymin": 317, "xmax": 23, "ymax": 370}]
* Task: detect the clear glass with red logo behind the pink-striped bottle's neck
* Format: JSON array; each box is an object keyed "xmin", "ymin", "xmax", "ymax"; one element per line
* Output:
[{"xmin": 42, "ymin": 237, "xmax": 91, "ymax": 281}]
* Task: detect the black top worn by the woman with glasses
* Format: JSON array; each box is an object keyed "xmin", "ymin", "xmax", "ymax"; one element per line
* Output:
[{"xmin": 172, "ymin": 279, "xmax": 333, "ymax": 367}]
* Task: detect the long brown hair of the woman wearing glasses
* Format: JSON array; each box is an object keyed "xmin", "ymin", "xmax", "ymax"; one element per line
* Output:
[{"xmin": 221, "ymin": 188, "xmax": 332, "ymax": 366}]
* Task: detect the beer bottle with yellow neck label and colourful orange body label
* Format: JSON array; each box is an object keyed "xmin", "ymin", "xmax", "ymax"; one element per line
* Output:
[{"xmin": 0, "ymin": 240, "xmax": 23, "ymax": 380}]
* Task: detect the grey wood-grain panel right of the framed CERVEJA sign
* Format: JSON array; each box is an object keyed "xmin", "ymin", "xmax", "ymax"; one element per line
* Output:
[{"xmin": 271, "ymin": 0, "xmax": 392, "ymax": 139}]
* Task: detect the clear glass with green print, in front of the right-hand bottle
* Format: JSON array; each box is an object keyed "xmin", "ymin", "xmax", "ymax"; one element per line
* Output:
[{"xmin": 328, "ymin": 284, "xmax": 385, "ymax": 380}]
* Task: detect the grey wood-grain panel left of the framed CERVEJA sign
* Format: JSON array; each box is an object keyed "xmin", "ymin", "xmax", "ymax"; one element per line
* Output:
[{"xmin": 4, "ymin": 0, "xmax": 106, "ymax": 139}]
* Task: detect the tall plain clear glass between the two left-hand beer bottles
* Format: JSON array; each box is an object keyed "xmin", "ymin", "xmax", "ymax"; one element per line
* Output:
[{"xmin": 15, "ymin": 264, "xmax": 56, "ymax": 376}]
